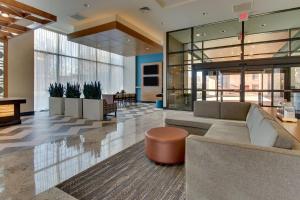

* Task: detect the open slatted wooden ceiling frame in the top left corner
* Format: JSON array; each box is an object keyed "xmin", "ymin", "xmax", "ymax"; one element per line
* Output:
[{"xmin": 0, "ymin": 0, "xmax": 57, "ymax": 40}]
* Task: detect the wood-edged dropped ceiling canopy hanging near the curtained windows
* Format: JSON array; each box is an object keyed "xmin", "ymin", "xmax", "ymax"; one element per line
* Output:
[{"xmin": 68, "ymin": 22, "xmax": 163, "ymax": 56}]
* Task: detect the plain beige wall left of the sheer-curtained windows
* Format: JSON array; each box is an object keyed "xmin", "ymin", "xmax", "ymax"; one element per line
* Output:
[{"xmin": 7, "ymin": 31, "xmax": 34, "ymax": 113}]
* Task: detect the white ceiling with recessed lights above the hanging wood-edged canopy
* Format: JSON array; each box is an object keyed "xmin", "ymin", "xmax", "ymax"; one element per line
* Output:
[{"xmin": 19, "ymin": 0, "xmax": 300, "ymax": 43}]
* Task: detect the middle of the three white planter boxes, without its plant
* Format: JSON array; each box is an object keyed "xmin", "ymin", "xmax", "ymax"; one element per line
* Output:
[{"xmin": 65, "ymin": 98, "xmax": 82, "ymax": 118}]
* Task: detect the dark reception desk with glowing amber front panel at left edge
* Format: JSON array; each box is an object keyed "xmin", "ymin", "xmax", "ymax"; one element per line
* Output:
[{"xmin": 0, "ymin": 98, "xmax": 26, "ymax": 127}]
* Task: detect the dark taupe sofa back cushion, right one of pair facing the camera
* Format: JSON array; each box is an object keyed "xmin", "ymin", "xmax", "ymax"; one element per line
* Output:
[{"xmin": 220, "ymin": 102, "xmax": 251, "ymax": 121}]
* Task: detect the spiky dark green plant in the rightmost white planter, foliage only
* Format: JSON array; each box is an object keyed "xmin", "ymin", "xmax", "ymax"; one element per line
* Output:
[{"xmin": 83, "ymin": 81, "xmax": 102, "ymax": 99}]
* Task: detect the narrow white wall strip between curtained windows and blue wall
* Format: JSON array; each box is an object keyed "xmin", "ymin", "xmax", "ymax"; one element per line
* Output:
[{"xmin": 123, "ymin": 56, "xmax": 136, "ymax": 93}]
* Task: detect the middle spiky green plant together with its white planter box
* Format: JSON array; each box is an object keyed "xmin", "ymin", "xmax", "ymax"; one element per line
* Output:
[{"xmin": 65, "ymin": 83, "xmax": 82, "ymax": 118}]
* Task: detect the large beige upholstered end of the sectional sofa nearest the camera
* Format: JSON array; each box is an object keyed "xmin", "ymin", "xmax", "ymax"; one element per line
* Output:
[{"xmin": 185, "ymin": 135, "xmax": 300, "ymax": 200}]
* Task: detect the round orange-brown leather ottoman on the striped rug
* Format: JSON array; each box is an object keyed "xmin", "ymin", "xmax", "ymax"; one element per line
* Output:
[{"xmin": 145, "ymin": 127, "xmax": 188, "ymax": 164}]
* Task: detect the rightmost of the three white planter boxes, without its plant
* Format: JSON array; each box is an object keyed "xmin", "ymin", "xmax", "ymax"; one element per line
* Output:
[{"xmin": 83, "ymin": 99, "xmax": 103, "ymax": 121}]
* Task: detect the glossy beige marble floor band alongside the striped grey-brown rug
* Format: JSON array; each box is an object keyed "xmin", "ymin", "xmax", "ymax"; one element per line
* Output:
[{"xmin": 0, "ymin": 111, "xmax": 167, "ymax": 200}]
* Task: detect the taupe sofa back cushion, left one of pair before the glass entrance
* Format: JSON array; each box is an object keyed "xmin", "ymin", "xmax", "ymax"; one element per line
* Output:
[{"xmin": 194, "ymin": 101, "xmax": 220, "ymax": 119}]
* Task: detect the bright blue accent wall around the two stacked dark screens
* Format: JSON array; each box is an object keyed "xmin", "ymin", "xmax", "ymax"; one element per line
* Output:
[{"xmin": 136, "ymin": 53, "xmax": 164, "ymax": 101}]
